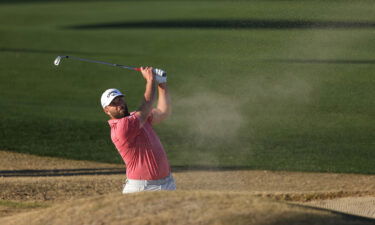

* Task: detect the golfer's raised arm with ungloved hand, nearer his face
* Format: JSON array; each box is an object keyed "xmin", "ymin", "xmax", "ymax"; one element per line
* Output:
[{"xmin": 135, "ymin": 67, "xmax": 156, "ymax": 127}]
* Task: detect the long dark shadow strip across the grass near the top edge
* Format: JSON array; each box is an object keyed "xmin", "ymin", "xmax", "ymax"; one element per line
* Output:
[{"xmin": 65, "ymin": 19, "xmax": 375, "ymax": 30}]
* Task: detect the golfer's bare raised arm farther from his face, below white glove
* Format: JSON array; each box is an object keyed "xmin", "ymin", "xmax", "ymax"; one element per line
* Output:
[{"xmin": 152, "ymin": 83, "xmax": 172, "ymax": 124}]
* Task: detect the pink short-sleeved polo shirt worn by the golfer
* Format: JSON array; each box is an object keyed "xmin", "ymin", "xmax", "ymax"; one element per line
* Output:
[{"xmin": 108, "ymin": 112, "xmax": 170, "ymax": 180}]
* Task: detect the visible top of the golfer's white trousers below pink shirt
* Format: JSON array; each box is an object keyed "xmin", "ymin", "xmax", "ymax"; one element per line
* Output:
[{"xmin": 122, "ymin": 175, "xmax": 176, "ymax": 194}]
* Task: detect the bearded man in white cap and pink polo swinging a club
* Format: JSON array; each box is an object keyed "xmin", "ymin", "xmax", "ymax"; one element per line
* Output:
[{"xmin": 101, "ymin": 67, "xmax": 176, "ymax": 194}]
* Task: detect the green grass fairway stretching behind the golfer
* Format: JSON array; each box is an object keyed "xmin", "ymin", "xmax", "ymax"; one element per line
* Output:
[{"xmin": 0, "ymin": 0, "xmax": 375, "ymax": 173}]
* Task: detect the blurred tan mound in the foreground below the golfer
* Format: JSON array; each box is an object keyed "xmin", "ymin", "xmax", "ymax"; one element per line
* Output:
[{"xmin": 0, "ymin": 191, "xmax": 371, "ymax": 225}]
